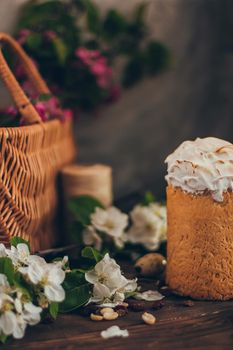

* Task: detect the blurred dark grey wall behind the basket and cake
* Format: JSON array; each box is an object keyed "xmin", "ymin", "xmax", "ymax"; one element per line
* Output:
[{"xmin": 0, "ymin": 0, "xmax": 233, "ymax": 199}]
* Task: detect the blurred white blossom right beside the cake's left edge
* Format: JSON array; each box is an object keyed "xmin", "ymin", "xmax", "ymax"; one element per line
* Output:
[{"xmin": 127, "ymin": 203, "xmax": 166, "ymax": 250}]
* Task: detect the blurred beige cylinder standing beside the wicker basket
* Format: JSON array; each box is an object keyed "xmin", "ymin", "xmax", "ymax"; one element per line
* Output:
[{"xmin": 61, "ymin": 164, "xmax": 112, "ymax": 206}]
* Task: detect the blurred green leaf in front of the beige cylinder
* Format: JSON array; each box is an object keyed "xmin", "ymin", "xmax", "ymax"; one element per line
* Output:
[{"xmin": 68, "ymin": 196, "xmax": 104, "ymax": 226}]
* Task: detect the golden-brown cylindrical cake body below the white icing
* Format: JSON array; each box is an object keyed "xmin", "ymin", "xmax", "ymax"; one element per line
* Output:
[{"xmin": 166, "ymin": 186, "xmax": 233, "ymax": 300}]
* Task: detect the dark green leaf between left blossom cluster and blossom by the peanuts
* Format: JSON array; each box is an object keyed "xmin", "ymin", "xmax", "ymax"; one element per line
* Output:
[{"xmin": 59, "ymin": 283, "xmax": 91, "ymax": 312}]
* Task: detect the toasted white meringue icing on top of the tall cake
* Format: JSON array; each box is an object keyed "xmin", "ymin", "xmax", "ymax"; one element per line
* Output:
[{"xmin": 165, "ymin": 137, "xmax": 233, "ymax": 202}]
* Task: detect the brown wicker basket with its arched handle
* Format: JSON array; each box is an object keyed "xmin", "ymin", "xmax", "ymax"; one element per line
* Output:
[{"xmin": 0, "ymin": 33, "xmax": 76, "ymax": 251}]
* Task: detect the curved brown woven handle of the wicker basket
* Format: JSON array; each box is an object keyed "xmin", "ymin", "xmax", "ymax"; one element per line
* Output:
[{"xmin": 0, "ymin": 32, "xmax": 50, "ymax": 124}]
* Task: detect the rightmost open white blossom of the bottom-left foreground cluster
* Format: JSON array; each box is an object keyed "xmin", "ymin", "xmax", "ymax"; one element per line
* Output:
[{"xmin": 19, "ymin": 257, "xmax": 65, "ymax": 302}]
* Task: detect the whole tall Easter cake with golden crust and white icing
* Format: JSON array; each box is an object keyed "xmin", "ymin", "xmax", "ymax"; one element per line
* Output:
[{"xmin": 165, "ymin": 137, "xmax": 233, "ymax": 300}]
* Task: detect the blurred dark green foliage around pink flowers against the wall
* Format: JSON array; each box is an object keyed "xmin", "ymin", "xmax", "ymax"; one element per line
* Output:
[{"xmin": 16, "ymin": 0, "xmax": 170, "ymax": 111}]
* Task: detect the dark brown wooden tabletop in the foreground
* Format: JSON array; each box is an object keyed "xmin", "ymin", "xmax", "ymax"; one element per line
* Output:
[{"xmin": 2, "ymin": 282, "xmax": 233, "ymax": 350}]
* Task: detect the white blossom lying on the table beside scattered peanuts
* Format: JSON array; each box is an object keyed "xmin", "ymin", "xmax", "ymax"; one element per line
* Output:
[{"xmin": 85, "ymin": 254, "xmax": 137, "ymax": 304}]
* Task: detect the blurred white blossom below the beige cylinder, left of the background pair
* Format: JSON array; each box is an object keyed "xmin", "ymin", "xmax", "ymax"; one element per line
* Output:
[{"xmin": 91, "ymin": 207, "xmax": 128, "ymax": 247}]
